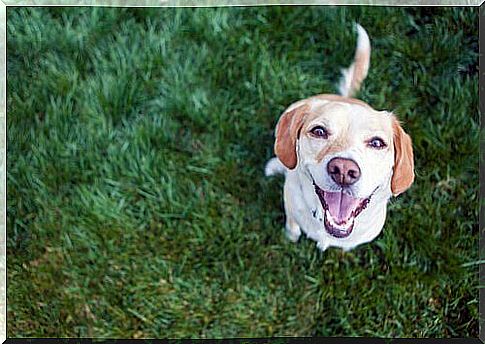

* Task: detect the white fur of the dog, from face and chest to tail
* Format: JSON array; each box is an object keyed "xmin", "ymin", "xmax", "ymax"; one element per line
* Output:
[{"xmin": 265, "ymin": 24, "xmax": 394, "ymax": 251}]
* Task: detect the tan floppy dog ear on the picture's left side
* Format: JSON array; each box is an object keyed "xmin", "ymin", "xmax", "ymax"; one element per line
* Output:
[{"xmin": 274, "ymin": 105, "xmax": 309, "ymax": 170}]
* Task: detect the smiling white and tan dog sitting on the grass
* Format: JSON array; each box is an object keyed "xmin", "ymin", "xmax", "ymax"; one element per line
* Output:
[{"xmin": 265, "ymin": 25, "xmax": 414, "ymax": 250}]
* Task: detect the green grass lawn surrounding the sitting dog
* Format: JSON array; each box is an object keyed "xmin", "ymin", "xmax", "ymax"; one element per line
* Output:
[{"xmin": 7, "ymin": 6, "xmax": 479, "ymax": 338}]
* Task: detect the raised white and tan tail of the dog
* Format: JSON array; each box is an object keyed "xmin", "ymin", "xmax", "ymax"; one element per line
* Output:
[{"xmin": 338, "ymin": 24, "xmax": 370, "ymax": 97}]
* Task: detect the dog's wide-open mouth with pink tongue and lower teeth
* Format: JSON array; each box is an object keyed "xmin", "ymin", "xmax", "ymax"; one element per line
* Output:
[{"xmin": 313, "ymin": 183, "xmax": 372, "ymax": 238}]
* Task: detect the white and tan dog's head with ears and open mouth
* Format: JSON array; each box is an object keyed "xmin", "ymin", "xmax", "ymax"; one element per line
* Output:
[{"xmin": 275, "ymin": 95, "xmax": 414, "ymax": 238}]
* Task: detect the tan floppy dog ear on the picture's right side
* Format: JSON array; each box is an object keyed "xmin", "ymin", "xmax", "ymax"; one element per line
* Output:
[{"xmin": 391, "ymin": 118, "xmax": 414, "ymax": 196}]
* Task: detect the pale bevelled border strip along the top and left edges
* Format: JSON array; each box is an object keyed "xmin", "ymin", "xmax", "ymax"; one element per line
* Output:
[{"xmin": 0, "ymin": 0, "xmax": 485, "ymax": 343}]
